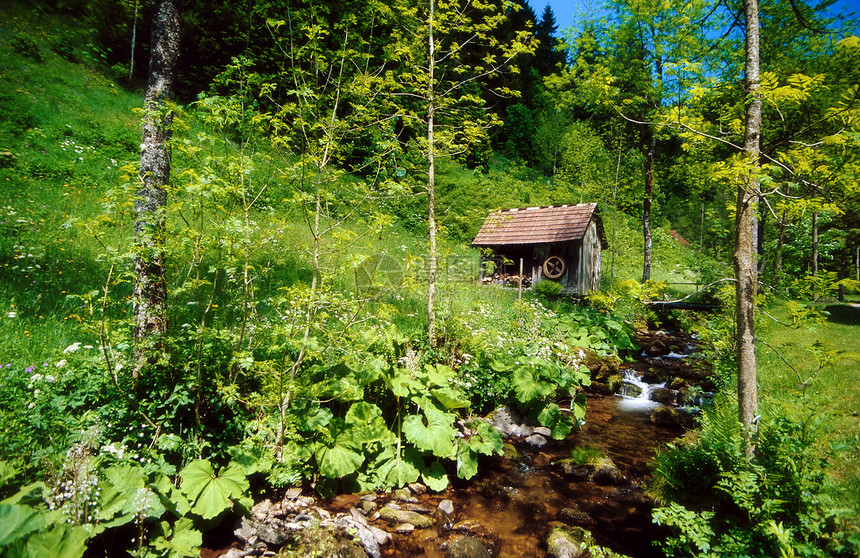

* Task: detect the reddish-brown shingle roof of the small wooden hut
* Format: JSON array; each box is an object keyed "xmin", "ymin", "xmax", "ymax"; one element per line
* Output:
[{"xmin": 472, "ymin": 203, "xmax": 607, "ymax": 248}]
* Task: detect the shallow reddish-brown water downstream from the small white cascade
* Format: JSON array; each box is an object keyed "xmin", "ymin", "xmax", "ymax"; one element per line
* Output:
[{"xmin": 326, "ymin": 396, "xmax": 678, "ymax": 558}]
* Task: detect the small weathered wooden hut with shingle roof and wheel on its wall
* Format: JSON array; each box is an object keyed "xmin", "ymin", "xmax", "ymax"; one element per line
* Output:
[{"xmin": 472, "ymin": 203, "xmax": 608, "ymax": 294}]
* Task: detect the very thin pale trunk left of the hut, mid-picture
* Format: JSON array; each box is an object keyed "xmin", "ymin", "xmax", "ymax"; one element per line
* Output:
[{"xmin": 427, "ymin": 0, "xmax": 436, "ymax": 348}]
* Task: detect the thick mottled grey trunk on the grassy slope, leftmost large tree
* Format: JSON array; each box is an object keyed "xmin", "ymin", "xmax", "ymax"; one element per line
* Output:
[{"xmin": 133, "ymin": 0, "xmax": 179, "ymax": 376}]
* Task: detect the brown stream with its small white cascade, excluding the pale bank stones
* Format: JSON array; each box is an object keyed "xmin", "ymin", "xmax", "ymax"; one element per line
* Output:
[{"xmin": 207, "ymin": 332, "xmax": 712, "ymax": 558}]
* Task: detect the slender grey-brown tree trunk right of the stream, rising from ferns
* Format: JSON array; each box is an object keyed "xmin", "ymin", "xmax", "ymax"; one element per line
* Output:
[{"xmin": 734, "ymin": 0, "xmax": 762, "ymax": 450}]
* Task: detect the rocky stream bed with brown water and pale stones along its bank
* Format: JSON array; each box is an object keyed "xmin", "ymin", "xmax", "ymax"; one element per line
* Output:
[{"xmin": 201, "ymin": 332, "xmax": 712, "ymax": 558}]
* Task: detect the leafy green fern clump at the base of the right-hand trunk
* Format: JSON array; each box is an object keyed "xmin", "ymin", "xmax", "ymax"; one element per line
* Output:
[{"xmin": 652, "ymin": 405, "xmax": 860, "ymax": 557}]
